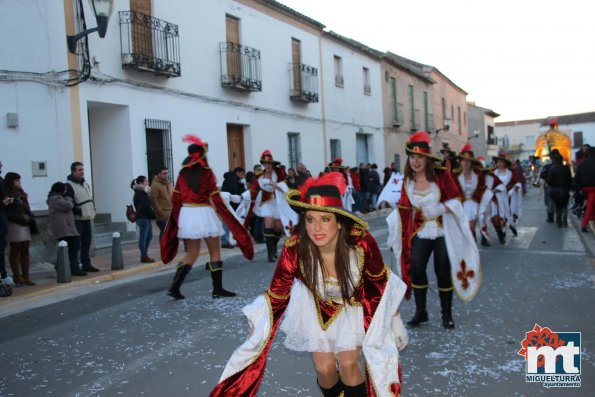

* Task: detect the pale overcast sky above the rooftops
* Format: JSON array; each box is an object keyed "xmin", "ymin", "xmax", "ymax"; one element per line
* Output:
[{"xmin": 278, "ymin": 0, "xmax": 595, "ymax": 122}]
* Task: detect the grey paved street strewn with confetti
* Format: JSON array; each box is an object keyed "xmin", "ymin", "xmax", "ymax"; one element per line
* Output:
[{"xmin": 0, "ymin": 187, "xmax": 595, "ymax": 397}]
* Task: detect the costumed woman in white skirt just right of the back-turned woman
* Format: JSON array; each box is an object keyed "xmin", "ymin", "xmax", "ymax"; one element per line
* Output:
[{"xmin": 244, "ymin": 150, "xmax": 288, "ymax": 262}]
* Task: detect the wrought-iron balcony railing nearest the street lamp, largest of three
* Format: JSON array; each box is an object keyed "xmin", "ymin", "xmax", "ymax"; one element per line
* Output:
[{"xmin": 120, "ymin": 11, "xmax": 182, "ymax": 77}]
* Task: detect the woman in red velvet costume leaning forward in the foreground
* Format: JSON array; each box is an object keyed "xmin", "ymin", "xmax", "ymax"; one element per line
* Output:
[{"xmin": 210, "ymin": 172, "xmax": 407, "ymax": 397}]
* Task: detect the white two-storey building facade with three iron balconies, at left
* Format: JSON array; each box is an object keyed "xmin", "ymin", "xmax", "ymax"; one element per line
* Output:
[{"xmin": 0, "ymin": 0, "xmax": 324, "ymax": 221}]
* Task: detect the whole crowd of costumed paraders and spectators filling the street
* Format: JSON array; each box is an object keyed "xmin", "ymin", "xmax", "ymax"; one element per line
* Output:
[{"xmin": 0, "ymin": 131, "xmax": 595, "ymax": 397}]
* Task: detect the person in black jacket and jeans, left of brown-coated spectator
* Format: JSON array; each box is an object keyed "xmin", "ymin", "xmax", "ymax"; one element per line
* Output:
[{"xmin": 130, "ymin": 175, "xmax": 156, "ymax": 263}]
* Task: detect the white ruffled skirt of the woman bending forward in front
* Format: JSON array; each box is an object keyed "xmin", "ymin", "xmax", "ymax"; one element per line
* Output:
[{"xmin": 280, "ymin": 280, "xmax": 365, "ymax": 353}]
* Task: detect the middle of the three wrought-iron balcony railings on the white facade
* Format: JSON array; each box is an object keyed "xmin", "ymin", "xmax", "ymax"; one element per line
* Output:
[{"xmin": 219, "ymin": 42, "xmax": 262, "ymax": 91}]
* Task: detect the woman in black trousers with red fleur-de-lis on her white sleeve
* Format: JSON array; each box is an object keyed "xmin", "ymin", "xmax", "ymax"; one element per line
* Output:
[{"xmin": 387, "ymin": 131, "xmax": 479, "ymax": 329}]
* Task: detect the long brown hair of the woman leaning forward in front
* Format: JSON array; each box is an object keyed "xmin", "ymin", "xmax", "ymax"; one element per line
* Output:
[{"xmin": 294, "ymin": 211, "xmax": 359, "ymax": 304}]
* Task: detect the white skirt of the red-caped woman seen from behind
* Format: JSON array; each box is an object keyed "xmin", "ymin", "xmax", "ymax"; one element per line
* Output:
[{"xmin": 178, "ymin": 206, "xmax": 225, "ymax": 240}]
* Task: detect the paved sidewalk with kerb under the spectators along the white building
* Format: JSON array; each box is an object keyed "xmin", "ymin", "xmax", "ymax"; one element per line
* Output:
[{"xmin": 0, "ymin": 209, "xmax": 390, "ymax": 311}]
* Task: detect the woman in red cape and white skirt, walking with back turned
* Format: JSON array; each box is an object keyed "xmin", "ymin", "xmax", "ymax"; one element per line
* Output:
[{"xmin": 161, "ymin": 135, "xmax": 254, "ymax": 299}]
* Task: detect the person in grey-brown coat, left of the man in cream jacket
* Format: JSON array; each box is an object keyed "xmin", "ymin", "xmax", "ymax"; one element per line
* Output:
[{"xmin": 46, "ymin": 182, "xmax": 87, "ymax": 276}]
